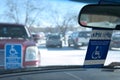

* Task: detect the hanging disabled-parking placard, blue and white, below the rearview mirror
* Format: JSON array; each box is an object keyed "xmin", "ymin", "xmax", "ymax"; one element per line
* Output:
[{"xmin": 84, "ymin": 29, "xmax": 113, "ymax": 68}]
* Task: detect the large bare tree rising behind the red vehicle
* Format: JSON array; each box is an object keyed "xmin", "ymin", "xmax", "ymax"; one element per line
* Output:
[{"xmin": 5, "ymin": 0, "xmax": 44, "ymax": 27}]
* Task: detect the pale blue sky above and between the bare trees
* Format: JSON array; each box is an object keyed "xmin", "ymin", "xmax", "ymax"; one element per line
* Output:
[{"xmin": 0, "ymin": 0, "xmax": 85, "ymax": 26}]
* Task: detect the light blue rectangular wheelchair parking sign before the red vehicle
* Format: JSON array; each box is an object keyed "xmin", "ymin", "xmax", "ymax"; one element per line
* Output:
[{"xmin": 5, "ymin": 44, "xmax": 22, "ymax": 69}]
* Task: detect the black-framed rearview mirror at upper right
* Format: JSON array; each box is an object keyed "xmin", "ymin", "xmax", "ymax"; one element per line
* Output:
[{"xmin": 78, "ymin": 4, "xmax": 120, "ymax": 29}]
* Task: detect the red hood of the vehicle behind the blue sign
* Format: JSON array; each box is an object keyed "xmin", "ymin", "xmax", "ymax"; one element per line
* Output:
[{"xmin": 0, "ymin": 39, "xmax": 35, "ymax": 49}]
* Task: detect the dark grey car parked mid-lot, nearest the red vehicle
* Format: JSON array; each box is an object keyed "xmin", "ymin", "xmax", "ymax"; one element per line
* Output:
[{"xmin": 46, "ymin": 34, "xmax": 62, "ymax": 48}]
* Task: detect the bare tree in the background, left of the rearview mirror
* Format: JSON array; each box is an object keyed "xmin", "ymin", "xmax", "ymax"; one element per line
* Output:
[{"xmin": 51, "ymin": 10, "xmax": 77, "ymax": 36}]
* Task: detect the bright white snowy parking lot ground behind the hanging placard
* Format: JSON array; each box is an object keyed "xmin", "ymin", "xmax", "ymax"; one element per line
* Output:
[{"xmin": 39, "ymin": 41, "xmax": 120, "ymax": 66}]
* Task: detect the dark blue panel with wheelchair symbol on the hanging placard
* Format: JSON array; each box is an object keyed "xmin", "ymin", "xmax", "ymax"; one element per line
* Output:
[{"xmin": 86, "ymin": 40, "xmax": 110, "ymax": 60}]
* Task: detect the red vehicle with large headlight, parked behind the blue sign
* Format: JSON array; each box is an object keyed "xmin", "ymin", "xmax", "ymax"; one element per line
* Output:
[{"xmin": 0, "ymin": 23, "xmax": 40, "ymax": 68}]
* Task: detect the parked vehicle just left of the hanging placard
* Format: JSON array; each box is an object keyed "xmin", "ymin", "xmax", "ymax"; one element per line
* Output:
[{"xmin": 68, "ymin": 31, "xmax": 91, "ymax": 48}]
